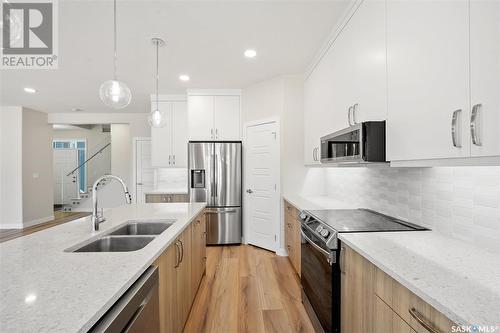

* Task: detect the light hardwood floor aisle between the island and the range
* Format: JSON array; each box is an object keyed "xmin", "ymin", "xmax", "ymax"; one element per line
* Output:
[{"xmin": 184, "ymin": 245, "xmax": 314, "ymax": 333}]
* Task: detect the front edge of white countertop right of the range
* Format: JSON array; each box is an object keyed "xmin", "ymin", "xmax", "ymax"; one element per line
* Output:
[{"xmin": 339, "ymin": 235, "xmax": 466, "ymax": 325}]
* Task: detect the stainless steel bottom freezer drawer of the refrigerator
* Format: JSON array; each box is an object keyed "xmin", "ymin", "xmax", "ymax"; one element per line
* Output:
[{"xmin": 205, "ymin": 207, "xmax": 241, "ymax": 245}]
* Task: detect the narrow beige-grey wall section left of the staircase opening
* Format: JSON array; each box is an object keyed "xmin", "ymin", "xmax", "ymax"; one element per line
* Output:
[{"xmin": 22, "ymin": 108, "xmax": 54, "ymax": 227}]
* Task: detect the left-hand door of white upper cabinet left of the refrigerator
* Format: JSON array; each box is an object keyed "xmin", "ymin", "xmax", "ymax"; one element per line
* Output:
[{"xmin": 151, "ymin": 102, "xmax": 172, "ymax": 167}]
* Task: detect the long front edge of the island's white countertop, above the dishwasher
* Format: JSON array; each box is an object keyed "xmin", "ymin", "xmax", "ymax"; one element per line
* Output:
[{"xmin": 78, "ymin": 202, "xmax": 206, "ymax": 333}]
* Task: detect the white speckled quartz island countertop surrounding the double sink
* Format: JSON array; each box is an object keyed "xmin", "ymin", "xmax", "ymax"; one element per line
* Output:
[{"xmin": 0, "ymin": 203, "xmax": 205, "ymax": 333}]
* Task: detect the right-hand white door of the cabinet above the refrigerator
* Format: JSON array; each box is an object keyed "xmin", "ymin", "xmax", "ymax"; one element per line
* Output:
[{"xmin": 214, "ymin": 96, "xmax": 241, "ymax": 141}]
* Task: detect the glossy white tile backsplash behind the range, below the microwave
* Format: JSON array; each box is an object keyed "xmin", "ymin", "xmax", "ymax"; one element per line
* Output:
[{"xmin": 325, "ymin": 166, "xmax": 500, "ymax": 252}]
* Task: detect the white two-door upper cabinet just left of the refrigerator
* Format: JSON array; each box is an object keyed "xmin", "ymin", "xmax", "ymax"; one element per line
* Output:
[{"xmin": 151, "ymin": 101, "xmax": 188, "ymax": 168}]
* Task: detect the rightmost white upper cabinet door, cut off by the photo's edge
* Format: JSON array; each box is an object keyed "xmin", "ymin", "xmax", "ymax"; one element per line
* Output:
[{"xmin": 470, "ymin": 0, "xmax": 500, "ymax": 156}]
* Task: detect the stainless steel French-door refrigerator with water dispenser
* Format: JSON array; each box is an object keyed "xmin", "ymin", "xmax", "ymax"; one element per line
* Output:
[{"xmin": 188, "ymin": 141, "xmax": 242, "ymax": 245}]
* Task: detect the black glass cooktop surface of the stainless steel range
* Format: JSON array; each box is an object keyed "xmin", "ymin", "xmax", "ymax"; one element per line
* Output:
[{"xmin": 307, "ymin": 209, "xmax": 428, "ymax": 232}]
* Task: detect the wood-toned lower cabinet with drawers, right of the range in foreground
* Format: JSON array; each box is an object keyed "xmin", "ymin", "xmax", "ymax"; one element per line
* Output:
[{"xmin": 340, "ymin": 245, "xmax": 456, "ymax": 333}]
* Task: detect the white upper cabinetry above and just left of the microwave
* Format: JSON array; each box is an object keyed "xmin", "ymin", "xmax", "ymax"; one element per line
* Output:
[{"xmin": 304, "ymin": 1, "xmax": 387, "ymax": 165}]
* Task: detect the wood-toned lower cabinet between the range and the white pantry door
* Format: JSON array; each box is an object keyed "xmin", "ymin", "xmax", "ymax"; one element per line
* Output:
[{"xmin": 284, "ymin": 200, "xmax": 301, "ymax": 276}]
